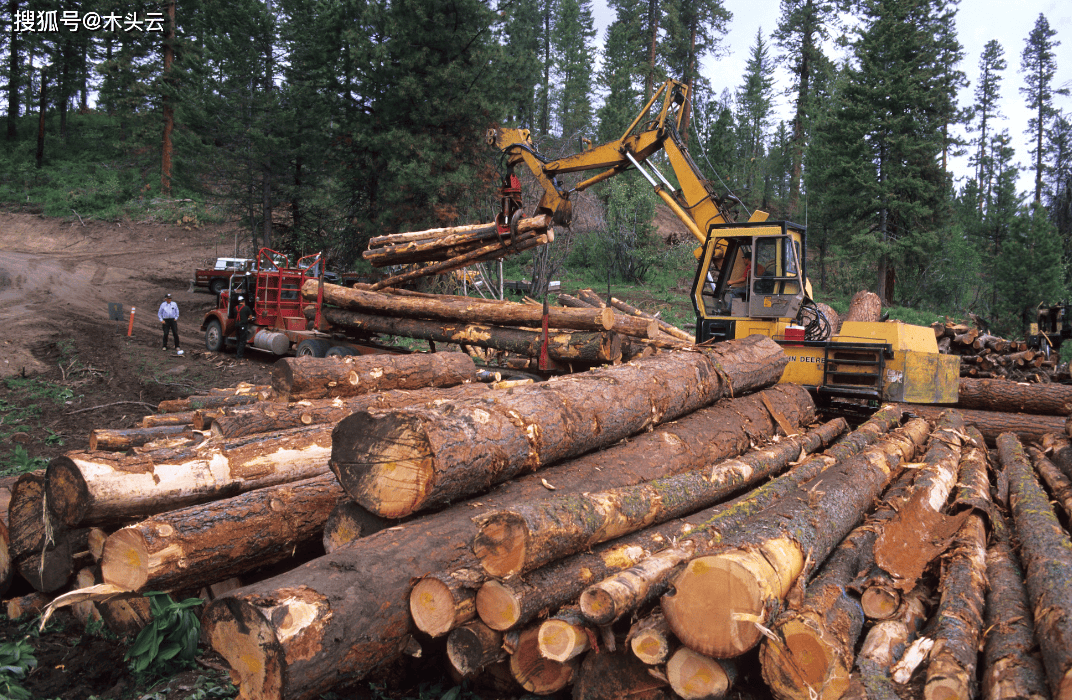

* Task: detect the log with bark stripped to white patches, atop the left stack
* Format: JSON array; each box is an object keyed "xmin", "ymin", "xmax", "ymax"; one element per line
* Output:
[{"xmin": 46, "ymin": 426, "xmax": 331, "ymax": 527}]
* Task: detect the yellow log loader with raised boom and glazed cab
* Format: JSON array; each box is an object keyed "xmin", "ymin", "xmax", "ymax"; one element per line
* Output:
[{"xmin": 488, "ymin": 80, "xmax": 959, "ymax": 405}]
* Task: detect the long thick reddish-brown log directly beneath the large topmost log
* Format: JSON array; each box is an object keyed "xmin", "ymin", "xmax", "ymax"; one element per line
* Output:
[{"xmin": 203, "ymin": 385, "xmax": 806, "ymax": 699}]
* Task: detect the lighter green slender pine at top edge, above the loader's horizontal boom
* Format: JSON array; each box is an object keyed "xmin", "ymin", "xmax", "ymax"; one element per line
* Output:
[{"xmin": 552, "ymin": 0, "xmax": 595, "ymax": 138}]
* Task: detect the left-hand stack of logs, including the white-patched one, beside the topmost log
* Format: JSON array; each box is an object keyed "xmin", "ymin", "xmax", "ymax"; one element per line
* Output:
[{"xmin": 0, "ymin": 353, "xmax": 486, "ymax": 632}]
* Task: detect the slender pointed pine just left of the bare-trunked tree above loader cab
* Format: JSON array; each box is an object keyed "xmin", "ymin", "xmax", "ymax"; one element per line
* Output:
[{"xmin": 736, "ymin": 28, "xmax": 774, "ymax": 204}]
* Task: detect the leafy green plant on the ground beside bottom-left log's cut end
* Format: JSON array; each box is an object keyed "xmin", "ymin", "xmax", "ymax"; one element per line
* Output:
[{"xmin": 124, "ymin": 593, "xmax": 204, "ymax": 677}]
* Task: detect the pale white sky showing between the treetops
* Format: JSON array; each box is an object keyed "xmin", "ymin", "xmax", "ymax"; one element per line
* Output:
[{"xmin": 593, "ymin": 0, "xmax": 1072, "ymax": 192}]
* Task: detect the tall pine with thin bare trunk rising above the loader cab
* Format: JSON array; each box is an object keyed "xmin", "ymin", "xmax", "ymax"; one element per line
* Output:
[{"xmin": 774, "ymin": 0, "xmax": 837, "ymax": 218}]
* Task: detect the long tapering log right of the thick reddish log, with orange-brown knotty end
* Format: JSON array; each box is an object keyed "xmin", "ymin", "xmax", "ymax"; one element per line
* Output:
[{"xmin": 473, "ymin": 419, "xmax": 848, "ymax": 577}]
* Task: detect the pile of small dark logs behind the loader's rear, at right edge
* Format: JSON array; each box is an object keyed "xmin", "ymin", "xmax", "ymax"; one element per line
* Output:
[{"xmin": 930, "ymin": 319, "xmax": 1067, "ymax": 382}]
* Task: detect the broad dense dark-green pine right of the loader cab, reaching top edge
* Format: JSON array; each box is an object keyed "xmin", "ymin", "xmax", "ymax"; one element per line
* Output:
[{"xmin": 821, "ymin": 0, "xmax": 952, "ymax": 302}]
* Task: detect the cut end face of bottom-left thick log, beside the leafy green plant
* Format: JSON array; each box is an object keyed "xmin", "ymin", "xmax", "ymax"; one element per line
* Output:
[{"xmin": 203, "ymin": 597, "xmax": 285, "ymax": 699}]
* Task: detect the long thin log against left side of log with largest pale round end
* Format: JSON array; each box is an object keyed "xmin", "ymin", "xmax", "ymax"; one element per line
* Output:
[{"xmin": 580, "ymin": 405, "xmax": 900, "ymax": 625}]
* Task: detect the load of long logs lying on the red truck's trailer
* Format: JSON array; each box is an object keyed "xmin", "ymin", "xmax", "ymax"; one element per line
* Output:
[{"xmin": 302, "ymin": 280, "xmax": 691, "ymax": 370}]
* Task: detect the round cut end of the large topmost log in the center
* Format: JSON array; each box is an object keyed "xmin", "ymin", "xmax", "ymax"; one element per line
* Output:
[{"xmin": 331, "ymin": 412, "xmax": 434, "ymax": 518}]
